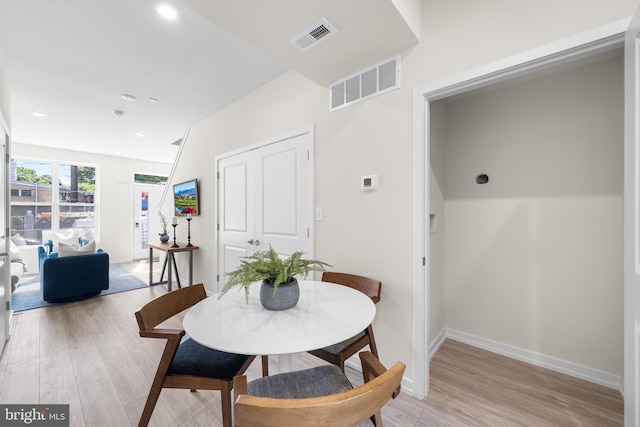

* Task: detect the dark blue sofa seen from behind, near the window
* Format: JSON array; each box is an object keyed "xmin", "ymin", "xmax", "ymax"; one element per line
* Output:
[{"xmin": 38, "ymin": 242, "xmax": 109, "ymax": 303}]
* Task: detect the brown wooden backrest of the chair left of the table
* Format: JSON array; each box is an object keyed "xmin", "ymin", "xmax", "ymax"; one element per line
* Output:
[{"xmin": 136, "ymin": 283, "xmax": 207, "ymax": 331}]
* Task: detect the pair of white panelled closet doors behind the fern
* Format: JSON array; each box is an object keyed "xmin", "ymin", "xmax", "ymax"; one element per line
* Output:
[{"xmin": 217, "ymin": 132, "xmax": 313, "ymax": 289}]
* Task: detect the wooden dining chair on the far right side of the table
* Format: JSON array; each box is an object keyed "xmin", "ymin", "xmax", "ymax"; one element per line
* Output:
[{"xmin": 309, "ymin": 271, "xmax": 382, "ymax": 371}]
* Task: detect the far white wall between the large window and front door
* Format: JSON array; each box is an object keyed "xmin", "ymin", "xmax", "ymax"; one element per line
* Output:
[{"xmin": 12, "ymin": 142, "xmax": 171, "ymax": 263}]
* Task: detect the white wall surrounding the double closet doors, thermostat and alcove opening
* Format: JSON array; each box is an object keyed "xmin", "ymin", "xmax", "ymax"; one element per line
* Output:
[{"xmin": 164, "ymin": 0, "xmax": 638, "ymax": 386}]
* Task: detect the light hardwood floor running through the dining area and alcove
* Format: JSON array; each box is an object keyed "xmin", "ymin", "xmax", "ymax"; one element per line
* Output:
[{"xmin": 0, "ymin": 263, "xmax": 623, "ymax": 427}]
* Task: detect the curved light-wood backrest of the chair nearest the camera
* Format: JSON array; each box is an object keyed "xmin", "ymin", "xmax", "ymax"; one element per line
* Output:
[{"xmin": 235, "ymin": 362, "xmax": 405, "ymax": 427}]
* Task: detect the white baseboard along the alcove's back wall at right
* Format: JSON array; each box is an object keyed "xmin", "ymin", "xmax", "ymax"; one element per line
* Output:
[{"xmin": 444, "ymin": 329, "xmax": 622, "ymax": 392}]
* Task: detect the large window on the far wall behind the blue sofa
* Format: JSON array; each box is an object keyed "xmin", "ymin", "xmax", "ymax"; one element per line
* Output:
[{"xmin": 11, "ymin": 158, "xmax": 97, "ymax": 245}]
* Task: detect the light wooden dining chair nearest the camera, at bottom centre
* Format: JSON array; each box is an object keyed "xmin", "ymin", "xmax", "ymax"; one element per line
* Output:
[{"xmin": 234, "ymin": 351, "xmax": 405, "ymax": 427}]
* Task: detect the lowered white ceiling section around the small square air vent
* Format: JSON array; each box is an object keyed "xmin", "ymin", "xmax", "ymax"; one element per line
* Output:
[{"xmin": 180, "ymin": 0, "xmax": 420, "ymax": 86}]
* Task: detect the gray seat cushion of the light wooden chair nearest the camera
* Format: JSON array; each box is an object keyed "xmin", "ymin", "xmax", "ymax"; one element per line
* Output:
[{"xmin": 248, "ymin": 365, "xmax": 374, "ymax": 427}]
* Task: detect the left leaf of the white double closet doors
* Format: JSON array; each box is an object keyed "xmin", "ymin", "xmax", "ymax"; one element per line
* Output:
[{"xmin": 218, "ymin": 151, "xmax": 255, "ymax": 289}]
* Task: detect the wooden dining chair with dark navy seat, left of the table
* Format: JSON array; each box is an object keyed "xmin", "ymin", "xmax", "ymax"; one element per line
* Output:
[{"xmin": 136, "ymin": 283, "xmax": 255, "ymax": 427}]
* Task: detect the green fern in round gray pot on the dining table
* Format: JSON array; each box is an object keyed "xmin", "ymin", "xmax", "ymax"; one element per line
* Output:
[{"xmin": 218, "ymin": 246, "xmax": 330, "ymax": 310}]
